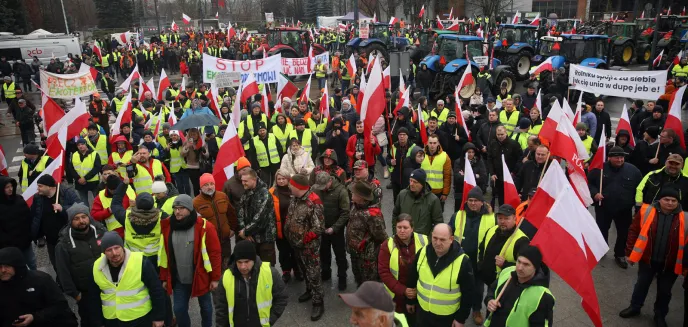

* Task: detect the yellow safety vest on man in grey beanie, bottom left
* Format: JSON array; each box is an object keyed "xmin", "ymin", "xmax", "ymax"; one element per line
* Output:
[{"xmin": 93, "ymin": 252, "xmax": 153, "ymax": 321}]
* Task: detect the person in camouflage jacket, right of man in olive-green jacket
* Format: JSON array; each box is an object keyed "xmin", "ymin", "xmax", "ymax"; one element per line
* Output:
[{"xmin": 346, "ymin": 181, "xmax": 387, "ymax": 286}]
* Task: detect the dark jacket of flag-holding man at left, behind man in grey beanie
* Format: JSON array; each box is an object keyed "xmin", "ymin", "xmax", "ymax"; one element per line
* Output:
[{"xmin": 31, "ymin": 185, "xmax": 82, "ymax": 244}]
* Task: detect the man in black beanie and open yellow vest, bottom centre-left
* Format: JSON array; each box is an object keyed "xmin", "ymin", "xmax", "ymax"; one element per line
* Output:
[{"xmin": 215, "ymin": 240, "xmax": 288, "ymax": 327}]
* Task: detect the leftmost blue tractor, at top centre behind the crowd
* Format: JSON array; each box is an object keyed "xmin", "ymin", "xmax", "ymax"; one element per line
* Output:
[{"xmin": 346, "ymin": 23, "xmax": 411, "ymax": 62}]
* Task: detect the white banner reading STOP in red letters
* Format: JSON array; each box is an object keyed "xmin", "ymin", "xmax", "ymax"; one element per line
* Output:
[{"xmin": 203, "ymin": 53, "xmax": 282, "ymax": 84}]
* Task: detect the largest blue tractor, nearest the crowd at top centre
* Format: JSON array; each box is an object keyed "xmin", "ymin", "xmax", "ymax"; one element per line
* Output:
[{"xmin": 420, "ymin": 34, "xmax": 516, "ymax": 98}]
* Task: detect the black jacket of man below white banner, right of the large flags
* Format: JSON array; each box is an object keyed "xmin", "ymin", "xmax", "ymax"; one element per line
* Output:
[{"xmin": 588, "ymin": 161, "xmax": 643, "ymax": 210}]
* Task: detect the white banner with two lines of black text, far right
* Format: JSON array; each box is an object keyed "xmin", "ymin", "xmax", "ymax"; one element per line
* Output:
[{"xmin": 569, "ymin": 65, "xmax": 666, "ymax": 99}]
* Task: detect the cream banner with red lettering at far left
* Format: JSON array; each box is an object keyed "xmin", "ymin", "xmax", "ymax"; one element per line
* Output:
[{"xmin": 41, "ymin": 70, "xmax": 98, "ymax": 99}]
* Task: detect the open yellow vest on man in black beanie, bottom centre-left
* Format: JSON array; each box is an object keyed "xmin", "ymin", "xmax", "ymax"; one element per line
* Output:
[{"xmin": 222, "ymin": 262, "xmax": 273, "ymax": 327}]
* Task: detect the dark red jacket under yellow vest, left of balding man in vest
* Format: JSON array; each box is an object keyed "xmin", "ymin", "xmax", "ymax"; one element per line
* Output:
[{"xmin": 377, "ymin": 236, "xmax": 416, "ymax": 312}]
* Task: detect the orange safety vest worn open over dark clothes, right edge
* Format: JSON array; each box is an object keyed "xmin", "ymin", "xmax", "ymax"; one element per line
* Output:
[{"xmin": 629, "ymin": 204, "xmax": 686, "ymax": 275}]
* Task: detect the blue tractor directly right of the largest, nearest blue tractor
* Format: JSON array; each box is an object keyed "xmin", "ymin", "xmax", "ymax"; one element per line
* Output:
[{"xmin": 493, "ymin": 24, "xmax": 538, "ymax": 80}]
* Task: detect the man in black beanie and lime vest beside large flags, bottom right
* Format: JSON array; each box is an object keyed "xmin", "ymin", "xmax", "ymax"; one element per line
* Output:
[{"xmin": 485, "ymin": 245, "xmax": 554, "ymax": 327}]
